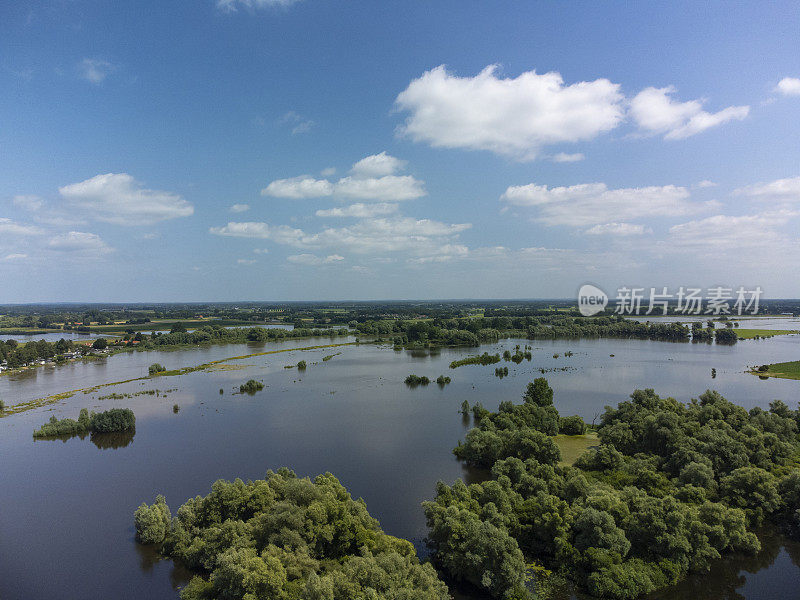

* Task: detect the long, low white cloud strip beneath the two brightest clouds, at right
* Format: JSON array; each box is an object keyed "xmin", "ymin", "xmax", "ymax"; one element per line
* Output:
[{"xmin": 501, "ymin": 183, "xmax": 717, "ymax": 227}]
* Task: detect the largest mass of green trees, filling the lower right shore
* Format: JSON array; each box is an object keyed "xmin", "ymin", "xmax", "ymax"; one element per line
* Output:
[{"xmin": 424, "ymin": 378, "xmax": 800, "ymax": 599}]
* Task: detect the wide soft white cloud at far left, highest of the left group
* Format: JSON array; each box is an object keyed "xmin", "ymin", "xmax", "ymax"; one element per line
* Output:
[{"xmin": 58, "ymin": 173, "xmax": 194, "ymax": 225}]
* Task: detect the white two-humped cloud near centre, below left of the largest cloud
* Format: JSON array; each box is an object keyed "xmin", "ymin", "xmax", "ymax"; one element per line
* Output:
[{"xmin": 261, "ymin": 152, "xmax": 426, "ymax": 202}]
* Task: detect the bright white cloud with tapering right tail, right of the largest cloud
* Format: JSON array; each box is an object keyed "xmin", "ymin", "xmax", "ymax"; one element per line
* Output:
[{"xmin": 630, "ymin": 86, "xmax": 750, "ymax": 140}]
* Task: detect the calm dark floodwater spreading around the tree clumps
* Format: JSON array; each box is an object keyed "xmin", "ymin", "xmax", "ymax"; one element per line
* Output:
[{"xmin": 0, "ymin": 336, "xmax": 800, "ymax": 600}]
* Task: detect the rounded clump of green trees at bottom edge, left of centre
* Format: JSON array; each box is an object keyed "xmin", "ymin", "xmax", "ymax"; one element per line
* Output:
[{"xmin": 134, "ymin": 468, "xmax": 450, "ymax": 600}]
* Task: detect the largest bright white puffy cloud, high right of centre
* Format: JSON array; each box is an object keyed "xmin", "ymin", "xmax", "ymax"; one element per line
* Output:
[{"xmin": 396, "ymin": 65, "xmax": 624, "ymax": 159}]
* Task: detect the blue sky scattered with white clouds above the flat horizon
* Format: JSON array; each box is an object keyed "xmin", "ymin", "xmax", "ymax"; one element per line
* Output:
[{"xmin": 0, "ymin": 0, "xmax": 800, "ymax": 302}]
